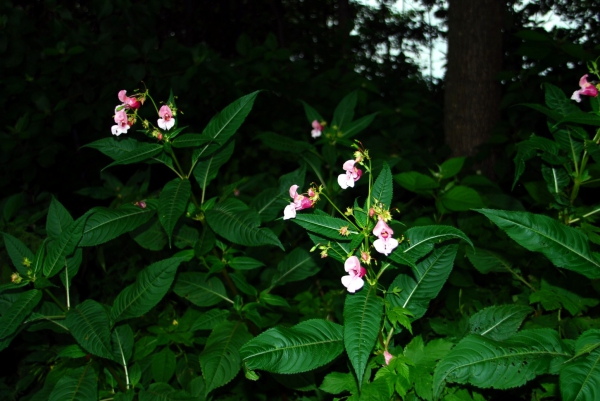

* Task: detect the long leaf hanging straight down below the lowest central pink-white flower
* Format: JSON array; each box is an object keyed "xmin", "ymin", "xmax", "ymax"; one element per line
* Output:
[{"xmin": 344, "ymin": 283, "xmax": 383, "ymax": 389}]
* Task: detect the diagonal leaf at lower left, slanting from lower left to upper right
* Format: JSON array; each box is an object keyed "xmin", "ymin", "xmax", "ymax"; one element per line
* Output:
[{"xmin": 110, "ymin": 258, "xmax": 183, "ymax": 323}]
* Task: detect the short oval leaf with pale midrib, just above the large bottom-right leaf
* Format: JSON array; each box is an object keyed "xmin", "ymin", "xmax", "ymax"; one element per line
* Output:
[{"xmin": 469, "ymin": 304, "xmax": 533, "ymax": 341}]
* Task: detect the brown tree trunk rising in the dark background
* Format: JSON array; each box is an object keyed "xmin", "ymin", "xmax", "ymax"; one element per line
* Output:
[{"xmin": 444, "ymin": 0, "xmax": 506, "ymax": 161}]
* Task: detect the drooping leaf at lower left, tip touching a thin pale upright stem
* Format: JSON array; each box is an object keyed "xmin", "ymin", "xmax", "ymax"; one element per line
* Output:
[{"xmin": 65, "ymin": 299, "xmax": 115, "ymax": 360}]
